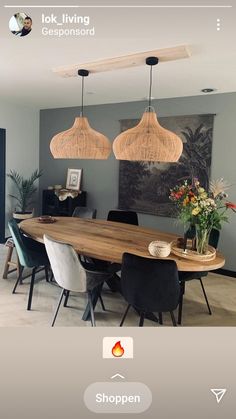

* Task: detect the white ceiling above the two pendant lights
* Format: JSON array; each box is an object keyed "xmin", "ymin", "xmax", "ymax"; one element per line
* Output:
[{"xmin": 0, "ymin": 0, "xmax": 236, "ymax": 109}]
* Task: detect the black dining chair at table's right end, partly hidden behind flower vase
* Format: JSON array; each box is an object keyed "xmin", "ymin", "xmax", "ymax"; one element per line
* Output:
[{"xmin": 178, "ymin": 227, "xmax": 220, "ymax": 324}]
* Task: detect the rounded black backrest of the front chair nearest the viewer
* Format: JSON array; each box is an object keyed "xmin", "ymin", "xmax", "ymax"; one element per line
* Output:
[{"xmin": 121, "ymin": 253, "xmax": 180, "ymax": 312}]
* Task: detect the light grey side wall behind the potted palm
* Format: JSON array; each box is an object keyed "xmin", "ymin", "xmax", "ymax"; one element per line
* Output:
[{"xmin": 0, "ymin": 100, "xmax": 39, "ymax": 230}]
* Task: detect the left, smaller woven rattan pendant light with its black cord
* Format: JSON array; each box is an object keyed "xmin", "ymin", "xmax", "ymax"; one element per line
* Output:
[{"xmin": 50, "ymin": 70, "xmax": 111, "ymax": 159}]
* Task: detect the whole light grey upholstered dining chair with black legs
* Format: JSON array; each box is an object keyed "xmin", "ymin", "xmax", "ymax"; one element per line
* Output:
[{"xmin": 44, "ymin": 235, "xmax": 111, "ymax": 326}]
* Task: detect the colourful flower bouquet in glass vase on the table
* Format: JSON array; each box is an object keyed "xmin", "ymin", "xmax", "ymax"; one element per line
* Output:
[{"xmin": 170, "ymin": 178, "xmax": 236, "ymax": 255}]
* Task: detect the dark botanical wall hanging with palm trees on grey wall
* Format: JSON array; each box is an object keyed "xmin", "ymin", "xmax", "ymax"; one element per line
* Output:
[{"xmin": 119, "ymin": 115, "xmax": 214, "ymax": 217}]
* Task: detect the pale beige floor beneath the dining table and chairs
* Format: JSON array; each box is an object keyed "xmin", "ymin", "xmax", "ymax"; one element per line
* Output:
[{"xmin": 0, "ymin": 245, "xmax": 236, "ymax": 327}]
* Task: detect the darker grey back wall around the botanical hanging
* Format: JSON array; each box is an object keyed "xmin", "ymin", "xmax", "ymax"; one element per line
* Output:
[{"xmin": 40, "ymin": 93, "xmax": 236, "ymax": 271}]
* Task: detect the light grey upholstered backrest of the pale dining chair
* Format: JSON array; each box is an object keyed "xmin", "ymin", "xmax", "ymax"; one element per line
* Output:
[{"xmin": 43, "ymin": 235, "xmax": 87, "ymax": 292}]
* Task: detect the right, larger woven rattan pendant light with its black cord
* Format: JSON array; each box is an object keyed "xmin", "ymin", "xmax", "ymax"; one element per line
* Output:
[{"xmin": 113, "ymin": 57, "xmax": 183, "ymax": 163}]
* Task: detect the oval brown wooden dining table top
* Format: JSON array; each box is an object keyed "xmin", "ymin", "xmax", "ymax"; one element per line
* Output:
[{"xmin": 20, "ymin": 217, "xmax": 225, "ymax": 272}]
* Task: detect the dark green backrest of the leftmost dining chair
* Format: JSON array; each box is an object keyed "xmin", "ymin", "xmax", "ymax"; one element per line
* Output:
[{"xmin": 8, "ymin": 218, "xmax": 37, "ymax": 268}]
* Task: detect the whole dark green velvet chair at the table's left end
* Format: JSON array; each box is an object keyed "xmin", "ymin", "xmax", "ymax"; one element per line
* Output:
[{"xmin": 8, "ymin": 219, "xmax": 50, "ymax": 310}]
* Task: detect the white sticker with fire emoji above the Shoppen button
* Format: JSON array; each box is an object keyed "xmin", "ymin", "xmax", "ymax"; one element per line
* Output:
[{"xmin": 102, "ymin": 336, "xmax": 134, "ymax": 362}]
